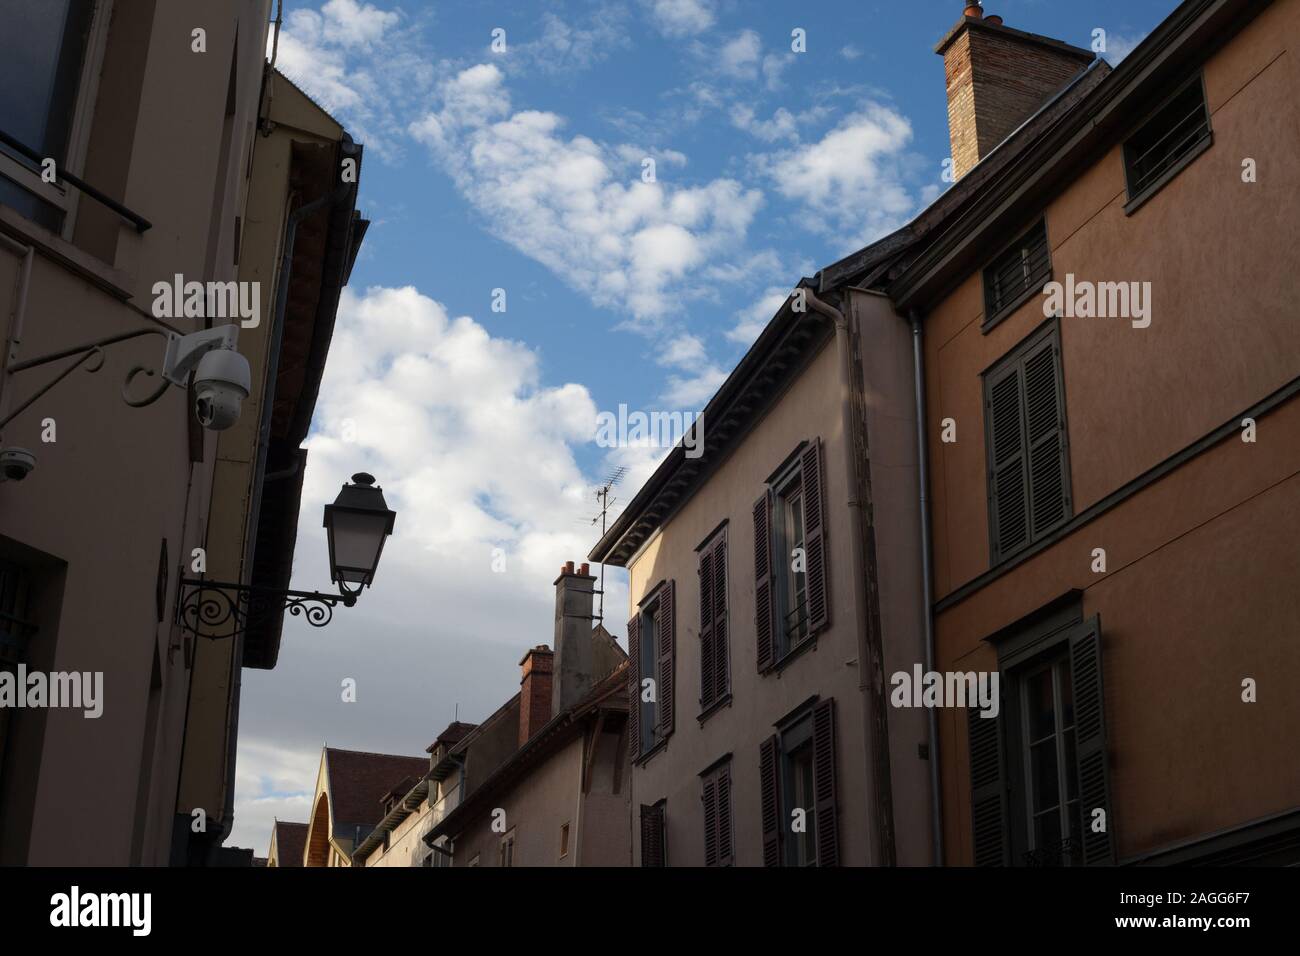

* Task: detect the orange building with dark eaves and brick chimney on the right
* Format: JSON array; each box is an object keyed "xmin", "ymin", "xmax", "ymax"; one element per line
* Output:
[{"xmin": 819, "ymin": 0, "xmax": 1300, "ymax": 865}]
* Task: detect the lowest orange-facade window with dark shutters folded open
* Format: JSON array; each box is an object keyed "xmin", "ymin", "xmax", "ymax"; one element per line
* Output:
[{"xmin": 967, "ymin": 614, "xmax": 1114, "ymax": 866}]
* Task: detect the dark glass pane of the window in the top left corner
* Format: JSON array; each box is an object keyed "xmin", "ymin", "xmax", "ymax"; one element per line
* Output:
[{"xmin": 0, "ymin": 0, "xmax": 94, "ymax": 165}]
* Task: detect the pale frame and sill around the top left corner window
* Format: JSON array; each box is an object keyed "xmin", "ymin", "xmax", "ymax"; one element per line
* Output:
[{"xmin": 0, "ymin": 0, "xmax": 113, "ymax": 242}]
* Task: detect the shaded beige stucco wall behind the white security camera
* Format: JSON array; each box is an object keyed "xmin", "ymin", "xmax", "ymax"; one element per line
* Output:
[{"xmin": 0, "ymin": 0, "xmax": 269, "ymax": 865}]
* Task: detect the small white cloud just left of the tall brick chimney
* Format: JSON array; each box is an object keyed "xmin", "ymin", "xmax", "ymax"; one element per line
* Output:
[{"xmin": 757, "ymin": 103, "xmax": 917, "ymax": 251}]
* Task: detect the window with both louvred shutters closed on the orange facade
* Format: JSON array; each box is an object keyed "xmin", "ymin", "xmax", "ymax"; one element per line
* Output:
[{"xmin": 984, "ymin": 321, "xmax": 1071, "ymax": 564}]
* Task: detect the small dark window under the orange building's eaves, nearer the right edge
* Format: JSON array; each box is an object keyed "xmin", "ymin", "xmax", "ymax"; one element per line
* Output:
[{"xmin": 1125, "ymin": 75, "xmax": 1213, "ymax": 212}]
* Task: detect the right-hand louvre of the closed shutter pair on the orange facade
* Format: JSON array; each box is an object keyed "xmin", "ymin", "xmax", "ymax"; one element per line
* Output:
[{"xmin": 1024, "ymin": 336, "xmax": 1070, "ymax": 538}]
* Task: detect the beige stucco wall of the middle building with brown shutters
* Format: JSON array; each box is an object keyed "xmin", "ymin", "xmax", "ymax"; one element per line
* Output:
[{"xmin": 628, "ymin": 341, "xmax": 874, "ymax": 866}]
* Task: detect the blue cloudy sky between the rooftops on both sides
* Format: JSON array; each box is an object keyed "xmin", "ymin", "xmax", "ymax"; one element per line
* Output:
[{"xmin": 228, "ymin": 0, "xmax": 1177, "ymax": 853}]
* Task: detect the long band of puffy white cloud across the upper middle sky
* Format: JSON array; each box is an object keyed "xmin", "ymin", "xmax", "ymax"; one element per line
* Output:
[{"xmin": 411, "ymin": 64, "xmax": 762, "ymax": 326}]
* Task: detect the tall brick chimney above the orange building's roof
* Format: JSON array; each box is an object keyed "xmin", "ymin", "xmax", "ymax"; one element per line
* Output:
[{"xmin": 935, "ymin": 3, "xmax": 1093, "ymax": 179}]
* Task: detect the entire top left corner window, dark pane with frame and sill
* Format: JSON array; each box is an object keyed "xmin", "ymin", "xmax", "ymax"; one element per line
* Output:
[{"xmin": 0, "ymin": 0, "xmax": 109, "ymax": 233}]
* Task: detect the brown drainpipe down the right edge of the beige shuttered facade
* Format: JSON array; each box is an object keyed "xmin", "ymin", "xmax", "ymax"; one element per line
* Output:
[{"xmin": 802, "ymin": 286, "xmax": 888, "ymax": 866}]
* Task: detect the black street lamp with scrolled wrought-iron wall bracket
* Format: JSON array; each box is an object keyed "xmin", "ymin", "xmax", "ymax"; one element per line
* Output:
[{"xmin": 176, "ymin": 472, "xmax": 397, "ymax": 640}]
